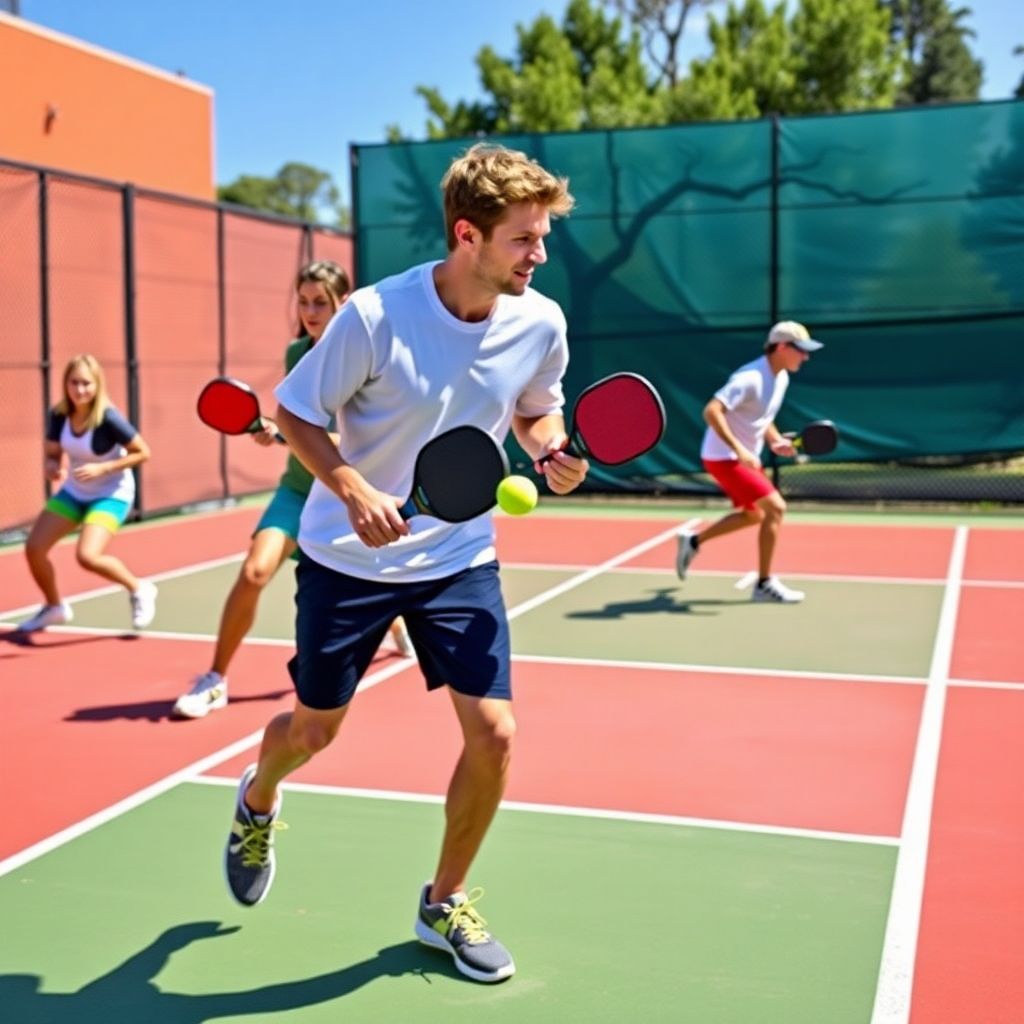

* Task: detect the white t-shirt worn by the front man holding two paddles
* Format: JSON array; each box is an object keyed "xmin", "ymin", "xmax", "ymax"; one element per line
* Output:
[{"xmin": 274, "ymin": 263, "xmax": 568, "ymax": 583}]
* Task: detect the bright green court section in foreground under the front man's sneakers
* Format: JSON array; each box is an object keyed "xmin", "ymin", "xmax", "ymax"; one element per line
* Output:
[{"xmin": 0, "ymin": 783, "xmax": 896, "ymax": 1024}]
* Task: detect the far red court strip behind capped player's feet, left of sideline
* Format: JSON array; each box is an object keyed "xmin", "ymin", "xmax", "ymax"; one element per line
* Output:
[{"xmin": 622, "ymin": 523, "xmax": 953, "ymax": 580}]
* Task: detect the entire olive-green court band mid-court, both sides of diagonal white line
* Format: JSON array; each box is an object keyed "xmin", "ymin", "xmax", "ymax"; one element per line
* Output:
[{"xmin": 64, "ymin": 562, "xmax": 942, "ymax": 678}]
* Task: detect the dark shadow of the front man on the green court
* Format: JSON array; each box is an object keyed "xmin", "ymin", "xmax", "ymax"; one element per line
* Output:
[{"xmin": 0, "ymin": 921, "xmax": 462, "ymax": 1024}]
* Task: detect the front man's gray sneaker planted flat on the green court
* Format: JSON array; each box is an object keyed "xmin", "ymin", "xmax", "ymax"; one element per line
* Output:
[{"xmin": 416, "ymin": 882, "xmax": 515, "ymax": 982}]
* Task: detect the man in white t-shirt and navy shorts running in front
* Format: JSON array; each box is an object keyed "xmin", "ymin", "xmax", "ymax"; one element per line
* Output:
[{"xmin": 225, "ymin": 145, "xmax": 588, "ymax": 982}]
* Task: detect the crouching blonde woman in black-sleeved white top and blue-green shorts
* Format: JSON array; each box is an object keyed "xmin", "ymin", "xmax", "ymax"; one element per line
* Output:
[{"xmin": 18, "ymin": 354, "xmax": 157, "ymax": 633}]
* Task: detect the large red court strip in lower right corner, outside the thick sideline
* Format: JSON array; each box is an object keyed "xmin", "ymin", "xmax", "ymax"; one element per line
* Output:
[{"xmin": 910, "ymin": 687, "xmax": 1024, "ymax": 1024}]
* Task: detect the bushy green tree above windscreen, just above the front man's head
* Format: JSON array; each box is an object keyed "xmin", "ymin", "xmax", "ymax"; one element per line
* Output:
[{"xmin": 416, "ymin": 0, "xmax": 665, "ymax": 138}]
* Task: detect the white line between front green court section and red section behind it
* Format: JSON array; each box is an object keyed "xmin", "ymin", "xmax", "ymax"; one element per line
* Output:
[{"xmin": 186, "ymin": 775, "xmax": 899, "ymax": 846}]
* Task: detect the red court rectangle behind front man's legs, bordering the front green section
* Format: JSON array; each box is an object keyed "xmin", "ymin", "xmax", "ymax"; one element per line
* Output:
[{"xmin": 213, "ymin": 662, "xmax": 922, "ymax": 836}]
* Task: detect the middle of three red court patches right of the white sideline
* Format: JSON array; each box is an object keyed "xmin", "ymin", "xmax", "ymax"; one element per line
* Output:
[{"xmin": 949, "ymin": 586, "xmax": 1024, "ymax": 683}]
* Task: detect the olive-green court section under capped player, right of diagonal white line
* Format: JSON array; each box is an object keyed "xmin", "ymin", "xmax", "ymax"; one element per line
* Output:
[{"xmin": 505, "ymin": 569, "xmax": 942, "ymax": 678}]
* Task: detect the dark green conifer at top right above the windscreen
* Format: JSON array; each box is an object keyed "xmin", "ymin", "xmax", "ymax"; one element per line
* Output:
[{"xmin": 882, "ymin": 0, "xmax": 983, "ymax": 104}]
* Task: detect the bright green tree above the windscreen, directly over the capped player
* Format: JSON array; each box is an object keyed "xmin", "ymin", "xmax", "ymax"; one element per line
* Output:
[{"xmin": 669, "ymin": 0, "xmax": 900, "ymax": 121}]
